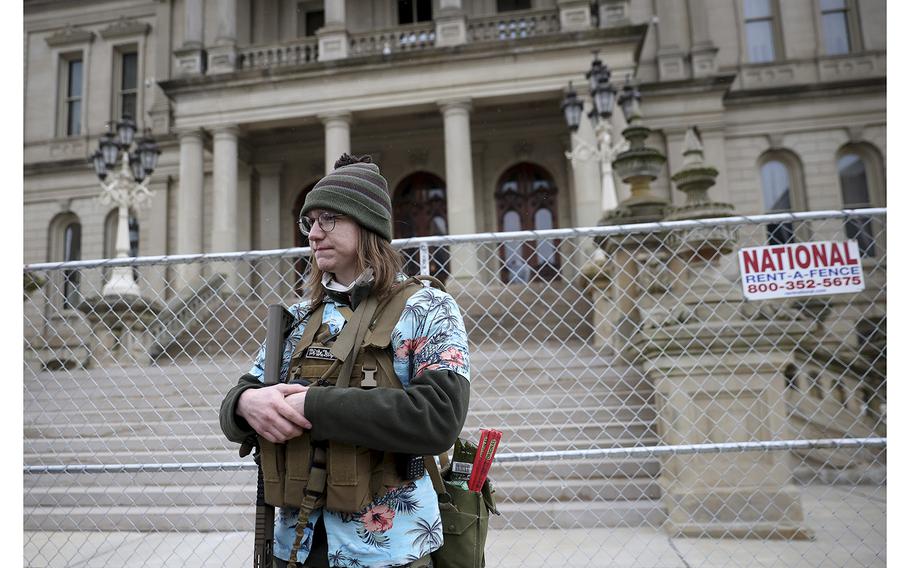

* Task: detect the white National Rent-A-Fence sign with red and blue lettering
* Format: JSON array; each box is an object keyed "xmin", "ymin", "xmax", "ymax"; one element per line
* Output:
[{"xmin": 739, "ymin": 241, "xmax": 866, "ymax": 300}]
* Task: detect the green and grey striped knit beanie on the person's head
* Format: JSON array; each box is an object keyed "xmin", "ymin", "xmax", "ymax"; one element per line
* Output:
[{"xmin": 300, "ymin": 154, "xmax": 392, "ymax": 241}]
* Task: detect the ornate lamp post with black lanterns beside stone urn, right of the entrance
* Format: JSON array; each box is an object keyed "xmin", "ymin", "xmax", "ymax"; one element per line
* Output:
[{"xmin": 562, "ymin": 51, "xmax": 641, "ymax": 211}]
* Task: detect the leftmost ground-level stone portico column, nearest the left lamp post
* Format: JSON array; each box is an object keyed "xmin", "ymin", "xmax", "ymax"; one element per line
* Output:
[{"xmin": 174, "ymin": 130, "xmax": 203, "ymax": 291}]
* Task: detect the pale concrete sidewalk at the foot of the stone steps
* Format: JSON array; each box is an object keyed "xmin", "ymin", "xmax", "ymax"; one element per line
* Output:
[{"xmin": 24, "ymin": 485, "xmax": 887, "ymax": 568}]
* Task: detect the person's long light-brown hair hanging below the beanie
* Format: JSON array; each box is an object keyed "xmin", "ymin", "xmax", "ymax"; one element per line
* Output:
[{"xmin": 304, "ymin": 225, "xmax": 403, "ymax": 307}]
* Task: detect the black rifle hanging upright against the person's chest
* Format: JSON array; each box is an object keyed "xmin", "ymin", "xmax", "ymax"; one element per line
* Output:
[{"xmin": 253, "ymin": 304, "xmax": 293, "ymax": 568}]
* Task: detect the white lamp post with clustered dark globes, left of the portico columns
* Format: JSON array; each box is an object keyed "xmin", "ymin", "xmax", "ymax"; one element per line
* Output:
[{"xmin": 91, "ymin": 115, "xmax": 161, "ymax": 296}]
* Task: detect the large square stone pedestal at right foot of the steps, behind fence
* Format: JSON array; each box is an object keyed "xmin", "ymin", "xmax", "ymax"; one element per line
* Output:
[{"xmin": 638, "ymin": 320, "xmax": 812, "ymax": 539}]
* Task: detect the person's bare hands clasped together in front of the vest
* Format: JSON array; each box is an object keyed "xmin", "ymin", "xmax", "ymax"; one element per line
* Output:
[{"xmin": 237, "ymin": 383, "xmax": 313, "ymax": 444}]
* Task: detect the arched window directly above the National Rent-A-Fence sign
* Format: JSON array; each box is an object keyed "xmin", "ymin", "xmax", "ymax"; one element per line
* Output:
[{"xmin": 759, "ymin": 150, "xmax": 807, "ymax": 245}]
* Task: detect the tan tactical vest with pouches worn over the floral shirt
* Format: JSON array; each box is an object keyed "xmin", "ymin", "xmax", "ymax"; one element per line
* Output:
[{"xmin": 259, "ymin": 279, "xmax": 438, "ymax": 513}]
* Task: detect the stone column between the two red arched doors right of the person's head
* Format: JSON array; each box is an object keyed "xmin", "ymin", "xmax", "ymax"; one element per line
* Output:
[{"xmin": 439, "ymin": 99, "xmax": 477, "ymax": 282}]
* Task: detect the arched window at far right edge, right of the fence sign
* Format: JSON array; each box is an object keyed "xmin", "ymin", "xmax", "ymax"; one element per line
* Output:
[{"xmin": 837, "ymin": 146, "xmax": 883, "ymax": 257}]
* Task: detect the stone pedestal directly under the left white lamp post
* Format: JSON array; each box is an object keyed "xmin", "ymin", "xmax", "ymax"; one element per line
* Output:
[{"xmin": 78, "ymin": 296, "xmax": 162, "ymax": 367}]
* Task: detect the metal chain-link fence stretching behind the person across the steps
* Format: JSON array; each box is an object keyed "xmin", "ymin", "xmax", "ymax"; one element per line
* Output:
[{"xmin": 24, "ymin": 210, "xmax": 887, "ymax": 567}]
